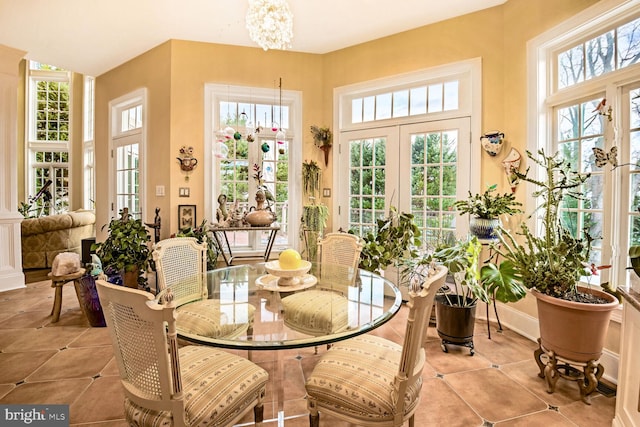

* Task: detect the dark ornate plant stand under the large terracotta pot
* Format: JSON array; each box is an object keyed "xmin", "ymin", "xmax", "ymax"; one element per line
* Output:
[{"xmin": 533, "ymin": 338, "xmax": 604, "ymax": 405}]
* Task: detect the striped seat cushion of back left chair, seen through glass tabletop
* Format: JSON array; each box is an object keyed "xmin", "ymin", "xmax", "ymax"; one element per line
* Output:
[{"xmin": 176, "ymin": 300, "xmax": 256, "ymax": 338}]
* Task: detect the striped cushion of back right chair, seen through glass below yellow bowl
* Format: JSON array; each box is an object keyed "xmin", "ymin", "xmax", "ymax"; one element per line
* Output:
[{"xmin": 282, "ymin": 290, "xmax": 349, "ymax": 335}]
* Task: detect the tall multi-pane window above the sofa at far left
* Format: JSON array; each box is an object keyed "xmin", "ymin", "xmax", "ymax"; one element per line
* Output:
[{"xmin": 26, "ymin": 61, "xmax": 71, "ymax": 216}]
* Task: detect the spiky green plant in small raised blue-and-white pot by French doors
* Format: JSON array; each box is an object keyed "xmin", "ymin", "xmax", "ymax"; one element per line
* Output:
[{"xmin": 454, "ymin": 184, "xmax": 522, "ymax": 240}]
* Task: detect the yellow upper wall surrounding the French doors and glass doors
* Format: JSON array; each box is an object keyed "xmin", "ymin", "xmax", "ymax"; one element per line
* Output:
[{"xmin": 96, "ymin": 0, "xmax": 596, "ymax": 238}]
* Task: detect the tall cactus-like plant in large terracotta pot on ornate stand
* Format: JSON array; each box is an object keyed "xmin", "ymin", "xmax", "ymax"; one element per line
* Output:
[{"xmin": 494, "ymin": 150, "xmax": 618, "ymax": 390}]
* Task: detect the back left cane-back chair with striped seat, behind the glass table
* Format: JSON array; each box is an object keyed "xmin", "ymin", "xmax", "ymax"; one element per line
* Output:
[{"xmin": 153, "ymin": 237, "xmax": 255, "ymax": 338}]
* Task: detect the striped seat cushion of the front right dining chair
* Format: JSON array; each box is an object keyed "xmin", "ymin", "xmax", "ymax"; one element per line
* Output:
[{"xmin": 305, "ymin": 335, "xmax": 425, "ymax": 421}]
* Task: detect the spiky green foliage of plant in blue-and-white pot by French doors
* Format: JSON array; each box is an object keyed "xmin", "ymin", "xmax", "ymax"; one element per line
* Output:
[{"xmin": 454, "ymin": 184, "xmax": 522, "ymax": 219}]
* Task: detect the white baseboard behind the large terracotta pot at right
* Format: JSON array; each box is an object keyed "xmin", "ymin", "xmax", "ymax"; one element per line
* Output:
[{"xmin": 476, "ymin": 303, "xmax": 620, "ymax": 384}]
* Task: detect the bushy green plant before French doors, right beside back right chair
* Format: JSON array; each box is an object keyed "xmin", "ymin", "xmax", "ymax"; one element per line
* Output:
[{"xmin": 360, "ymin": 206, "xmax": 421, "ymax": 273}]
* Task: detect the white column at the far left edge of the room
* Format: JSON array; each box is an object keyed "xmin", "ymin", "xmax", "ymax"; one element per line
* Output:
[{"xmin": 0, "ymin": 45, "xmax": 26, "ymax": 292}]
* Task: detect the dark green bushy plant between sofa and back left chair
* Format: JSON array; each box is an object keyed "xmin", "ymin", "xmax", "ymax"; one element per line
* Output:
[{"xmin": 91, "ymin": 208, "xmax": 151, "ymax": 289}]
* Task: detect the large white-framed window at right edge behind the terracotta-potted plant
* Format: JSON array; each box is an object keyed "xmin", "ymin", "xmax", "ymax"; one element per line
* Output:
[{"xmin": 530, "ymin": 0, "xmax": 640, "ymax": 290}]
